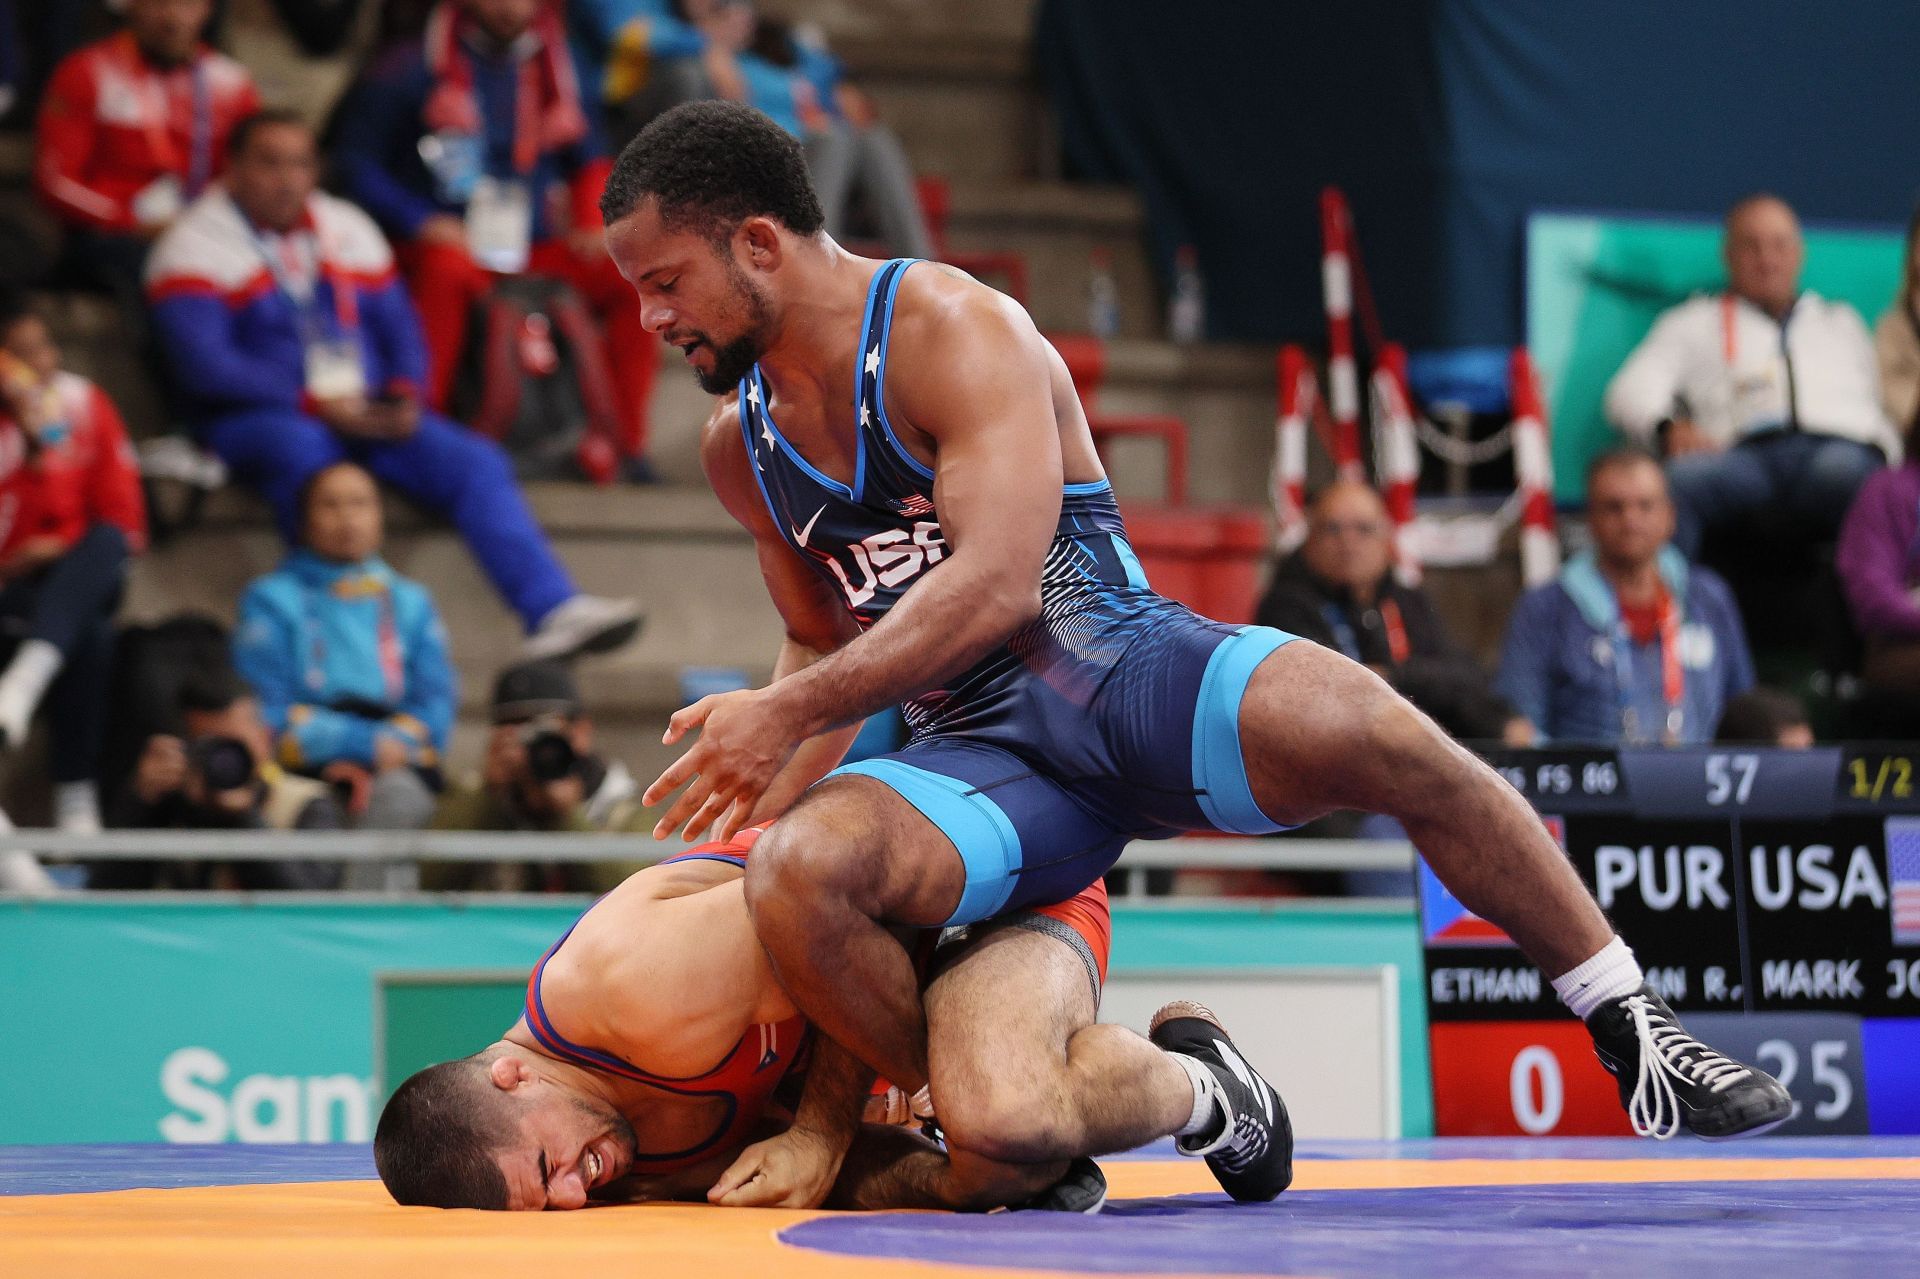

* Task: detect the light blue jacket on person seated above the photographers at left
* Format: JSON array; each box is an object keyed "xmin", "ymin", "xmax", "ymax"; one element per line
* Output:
[{"xmin": 234, "ymin": 551, "xmax": 457, "ymax": 770}]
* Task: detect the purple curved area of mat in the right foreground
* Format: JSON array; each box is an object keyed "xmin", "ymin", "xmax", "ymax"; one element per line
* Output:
[{"xmin": 780, "ymin": 1181, "xmax": 1920, "ymax": 1279}]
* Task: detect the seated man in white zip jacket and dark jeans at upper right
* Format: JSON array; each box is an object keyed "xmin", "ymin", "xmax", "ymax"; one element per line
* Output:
[{"xmin": 1607, "ymin": 196, "xmax": 1899, "ymax": 559}]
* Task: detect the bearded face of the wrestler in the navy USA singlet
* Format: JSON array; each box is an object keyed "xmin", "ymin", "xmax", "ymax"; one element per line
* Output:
[{"xmin": 607, "ymin": 200, "xmax": 778, "ymax": 396}]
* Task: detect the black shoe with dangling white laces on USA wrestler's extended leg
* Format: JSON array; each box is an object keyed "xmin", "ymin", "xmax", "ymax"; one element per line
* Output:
[{"xmin": 1586, "ymin": 985, "xmax": 1793, "ymax": 1141}]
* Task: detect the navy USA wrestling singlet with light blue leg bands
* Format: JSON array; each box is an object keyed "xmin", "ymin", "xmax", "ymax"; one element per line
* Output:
[{"xmin": 739, "ymin": 259, "xmax": 1292, "ymax": 924}]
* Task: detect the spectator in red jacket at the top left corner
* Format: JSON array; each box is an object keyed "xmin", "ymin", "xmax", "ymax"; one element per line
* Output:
[{"xmin": 35, "ymin": 0, "xmax": 259, "ymax": 299}]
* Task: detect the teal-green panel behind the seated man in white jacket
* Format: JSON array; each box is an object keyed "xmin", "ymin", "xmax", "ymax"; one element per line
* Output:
[{"xmin": 1526, "ymin": 213, "xmax": 1903, "ymax": 503}]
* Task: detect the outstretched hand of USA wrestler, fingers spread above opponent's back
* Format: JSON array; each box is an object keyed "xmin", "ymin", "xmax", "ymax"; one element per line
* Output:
[{"xmin": 641, "ymin": 688, "xmax": 806, "ymax": 843}]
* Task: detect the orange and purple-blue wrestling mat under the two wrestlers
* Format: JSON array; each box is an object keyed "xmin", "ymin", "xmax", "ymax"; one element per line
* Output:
[{"xmin": 0, "ymin": 1137, "xmax": 1920, "ymax": 1279}]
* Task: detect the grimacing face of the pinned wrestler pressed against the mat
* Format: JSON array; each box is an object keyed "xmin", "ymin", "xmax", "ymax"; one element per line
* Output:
[{"xmin": 492, "ymin": 1058, "xmax": 636, "ymax": 1212}]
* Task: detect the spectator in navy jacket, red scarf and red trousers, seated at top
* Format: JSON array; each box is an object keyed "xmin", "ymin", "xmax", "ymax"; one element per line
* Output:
[{"xmin": 334, "ymin": 0, "xmax": 660, "ymax": 478}]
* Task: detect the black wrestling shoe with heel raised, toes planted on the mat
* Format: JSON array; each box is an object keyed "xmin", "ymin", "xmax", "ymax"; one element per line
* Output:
[{"xmin": 1146, "ymin": 1001, "xmax": 1294, "ymax": 1204}]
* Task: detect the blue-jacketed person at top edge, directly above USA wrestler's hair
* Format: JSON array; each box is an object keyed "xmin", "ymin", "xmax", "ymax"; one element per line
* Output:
[{"xmin": 566, "ymin": 0, "xmax": 728, "ymax": 148}]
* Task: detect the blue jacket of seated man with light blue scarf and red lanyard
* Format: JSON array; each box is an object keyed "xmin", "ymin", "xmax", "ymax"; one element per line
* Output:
[{"xmin": 1494, "ymin": 545, "xmax": 1753, "ymax": 745}]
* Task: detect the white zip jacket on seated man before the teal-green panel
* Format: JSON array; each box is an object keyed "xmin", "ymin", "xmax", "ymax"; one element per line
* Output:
[{"xmin": 1607, "ymin": 292, "xmax": 1901, "ymax": 461}]
